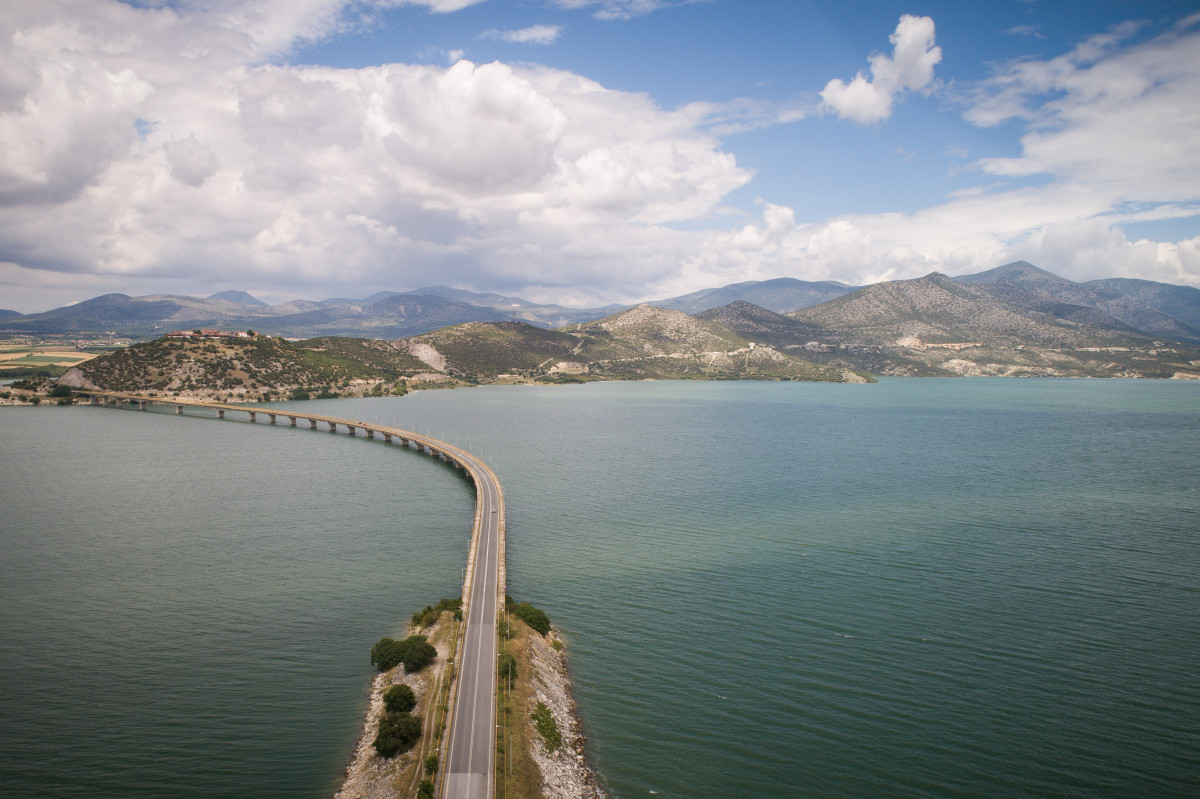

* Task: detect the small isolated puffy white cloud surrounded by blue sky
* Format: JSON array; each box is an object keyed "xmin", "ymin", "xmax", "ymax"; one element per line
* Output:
[{"xmin": 821, "ymin": 14, "xmax": 942, "ymax": 125}]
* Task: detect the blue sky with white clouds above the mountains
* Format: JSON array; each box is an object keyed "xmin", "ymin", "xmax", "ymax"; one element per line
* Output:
[{"xmin": 0, "ymin": 0, "xmax": 1200, "ymax": 313}]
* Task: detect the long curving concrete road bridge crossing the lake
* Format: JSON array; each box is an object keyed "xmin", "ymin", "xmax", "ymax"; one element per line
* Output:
[{"xmin": 77, "ymin": 390, "xmax": 504, "ymax": 799}]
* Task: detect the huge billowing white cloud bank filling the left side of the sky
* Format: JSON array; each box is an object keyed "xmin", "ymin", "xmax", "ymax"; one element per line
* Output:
[{"xmin": 0, "ymin": 0, "xmax": 751, "ymax": 307}]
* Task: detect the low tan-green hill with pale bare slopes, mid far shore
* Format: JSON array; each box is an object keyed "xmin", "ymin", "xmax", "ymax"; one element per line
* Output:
[{"xmin": 395, "ymin": 305, "xmax": 864, "ymax": 382}]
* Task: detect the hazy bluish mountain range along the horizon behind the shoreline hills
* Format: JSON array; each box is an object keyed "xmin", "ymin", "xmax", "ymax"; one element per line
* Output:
[{"xmin": 7, "ymin": 262, "xmax": 1200, "ymax": 343}]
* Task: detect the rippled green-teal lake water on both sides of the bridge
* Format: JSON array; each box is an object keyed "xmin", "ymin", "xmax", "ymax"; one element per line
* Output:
[{"xmin": 0, "ymin": 379, "xmax": 1200, "ymax": 799}]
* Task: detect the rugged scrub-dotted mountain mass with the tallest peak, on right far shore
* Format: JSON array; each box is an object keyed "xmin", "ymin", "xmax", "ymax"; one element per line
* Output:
[{"xmin": 788, "ymin": 271, "xmax": 1200, "ymax": 377}]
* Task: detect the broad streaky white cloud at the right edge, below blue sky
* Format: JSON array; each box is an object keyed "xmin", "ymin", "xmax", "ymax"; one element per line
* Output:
[{"xmin": 967, "ymin": 23, "xmax": 1200, "ymax": 205}]
